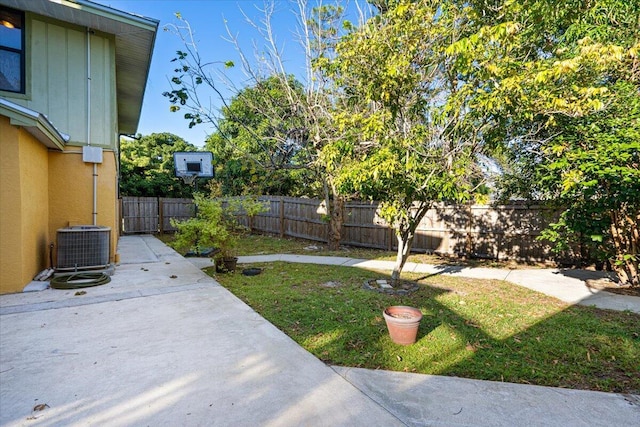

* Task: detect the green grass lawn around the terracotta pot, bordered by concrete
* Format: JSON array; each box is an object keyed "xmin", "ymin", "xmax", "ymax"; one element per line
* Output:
[{"xmin": 208, "ymin": 262, "xmax": 640, "ymax": 394}]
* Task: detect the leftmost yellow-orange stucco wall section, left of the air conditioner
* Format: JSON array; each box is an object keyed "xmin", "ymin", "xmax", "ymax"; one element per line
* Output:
[{"xmin": 0, "ymin": 116, "xmax": 50, "ymax": 293}]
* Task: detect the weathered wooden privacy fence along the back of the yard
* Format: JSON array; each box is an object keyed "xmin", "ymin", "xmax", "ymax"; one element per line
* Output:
[{"xmin": 122, "ymin": 196, "xmax": 555, "ymax": 261}]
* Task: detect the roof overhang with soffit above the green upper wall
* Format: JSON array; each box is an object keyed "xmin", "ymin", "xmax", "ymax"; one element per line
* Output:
[{"xmin": 0, "ymin": 0, "xmax": 159, "ymax": 134}]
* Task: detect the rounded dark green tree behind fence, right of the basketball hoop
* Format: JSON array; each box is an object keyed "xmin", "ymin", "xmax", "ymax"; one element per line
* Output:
[{"xmin": 206, "ymin": 76, "xmax": 312, "ymax": 195}]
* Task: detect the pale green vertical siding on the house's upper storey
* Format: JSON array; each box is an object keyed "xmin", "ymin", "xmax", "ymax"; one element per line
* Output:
[{"xmin": 7, "ymin": 17, "xmax": 117, "ymax": 148}]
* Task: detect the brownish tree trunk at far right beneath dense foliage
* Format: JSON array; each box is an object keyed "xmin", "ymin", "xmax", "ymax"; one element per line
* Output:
[{"xmin": 611, "ymin": 207, "xmax": 640, "ymax": 286}]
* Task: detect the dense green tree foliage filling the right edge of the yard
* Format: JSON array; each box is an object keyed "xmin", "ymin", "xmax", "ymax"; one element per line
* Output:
[{"xmin": 449, "ymin": 0, "xmax": 640, "ymax": 285}]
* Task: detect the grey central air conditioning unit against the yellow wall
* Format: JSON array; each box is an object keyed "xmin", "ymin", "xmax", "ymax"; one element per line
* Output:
[{"xmin": 56, "ymin": 225, "xmax": 111, "ymax": 271}]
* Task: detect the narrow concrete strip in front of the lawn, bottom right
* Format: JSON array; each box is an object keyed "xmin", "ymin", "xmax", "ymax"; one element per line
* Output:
[{"xmin": 333, "ymin": 367, "xmax": 640, "ymax": 427}]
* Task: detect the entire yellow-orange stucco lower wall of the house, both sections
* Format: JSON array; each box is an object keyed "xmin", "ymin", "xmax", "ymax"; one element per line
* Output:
[{"xmin": 0, "ymin": 116, "xmax": 119, "ymax": 293}]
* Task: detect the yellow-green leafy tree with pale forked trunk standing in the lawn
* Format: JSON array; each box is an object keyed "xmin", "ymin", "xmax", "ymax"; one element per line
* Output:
[{"xmin": 323, "ymin": 1, "xmax": 481, "ymax": 279}]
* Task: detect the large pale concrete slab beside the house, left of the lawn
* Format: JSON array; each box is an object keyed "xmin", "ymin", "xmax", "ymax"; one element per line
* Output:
[{"xmin": 0, "ymin": 236, "xmax": 402, "ymax": 426}]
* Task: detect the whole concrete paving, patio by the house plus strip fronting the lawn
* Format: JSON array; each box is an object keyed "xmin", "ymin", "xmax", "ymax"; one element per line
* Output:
[{"xmin": 0, "ymin": 236, "xmax": 640, "ymax": 426}]
